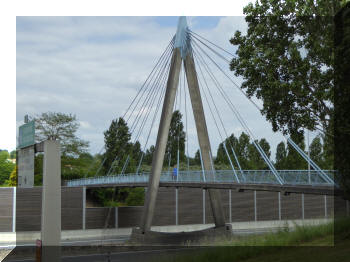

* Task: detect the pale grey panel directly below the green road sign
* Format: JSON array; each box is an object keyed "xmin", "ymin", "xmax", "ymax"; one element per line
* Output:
[{"xmin": 18, "ymin": 146, "xmax": 34, "ymax": 187}]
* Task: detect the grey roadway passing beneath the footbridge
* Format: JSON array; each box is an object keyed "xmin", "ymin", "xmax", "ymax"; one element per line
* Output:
[{"xmin": 0, "ymin": 219, "xmax": 332, "ymax": 262}]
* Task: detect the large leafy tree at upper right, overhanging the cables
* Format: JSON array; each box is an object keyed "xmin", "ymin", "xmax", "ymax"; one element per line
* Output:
[{"xmin": 230, "ymin": 0, "xmax": 339, "ymax": 133}]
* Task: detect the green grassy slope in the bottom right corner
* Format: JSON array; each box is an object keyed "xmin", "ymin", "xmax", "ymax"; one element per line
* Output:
[{"xmin": 159, "ymin": 219, "xmax": 350, "ymax": 262}]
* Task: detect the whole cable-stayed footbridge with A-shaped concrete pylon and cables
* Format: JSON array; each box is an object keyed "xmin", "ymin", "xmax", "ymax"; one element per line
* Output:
[{"xmin": 66, "ymin": 17, "xmax": 337, "ymax": 243}]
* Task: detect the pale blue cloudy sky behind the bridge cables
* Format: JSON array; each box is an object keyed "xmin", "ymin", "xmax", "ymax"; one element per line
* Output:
[{"xmin": 16, "ymin": 16, "xmax": 318, "ymax": 160}]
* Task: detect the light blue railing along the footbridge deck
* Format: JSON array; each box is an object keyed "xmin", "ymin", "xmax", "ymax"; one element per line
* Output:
[{"xmin": 66, "ymin": 170, "xmax": 335, "ymax": 186}]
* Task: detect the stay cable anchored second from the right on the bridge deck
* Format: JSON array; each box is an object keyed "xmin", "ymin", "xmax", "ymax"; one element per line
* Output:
[{"xmin": 190, "ymin": 44, "xmax": 283, "ymax": 184}]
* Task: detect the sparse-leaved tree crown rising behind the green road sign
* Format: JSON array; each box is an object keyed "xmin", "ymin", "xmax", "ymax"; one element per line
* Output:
[{"xmin": 35, "ymin": 112, "xmax": 89, "ymax": 157}]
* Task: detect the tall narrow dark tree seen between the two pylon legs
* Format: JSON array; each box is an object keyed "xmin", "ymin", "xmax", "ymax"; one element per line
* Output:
[{"xmin": 164, "ymin": 110, "xmax": 186, "ymax": 165}]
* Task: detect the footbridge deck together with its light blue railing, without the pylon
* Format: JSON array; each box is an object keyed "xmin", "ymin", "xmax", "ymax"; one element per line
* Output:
[{"xmin": 66, "ymin": 170, "xmax": 334, "ymax": 195}]
